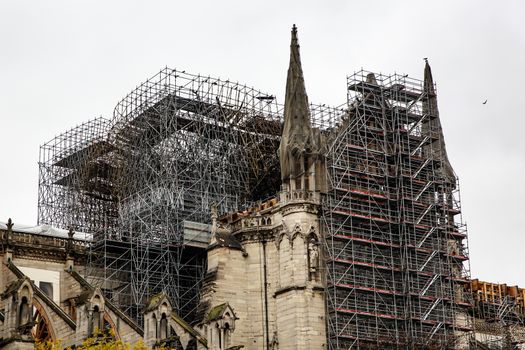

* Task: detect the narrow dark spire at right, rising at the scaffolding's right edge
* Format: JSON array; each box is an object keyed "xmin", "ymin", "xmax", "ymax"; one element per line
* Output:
[{"xmin": 421, "ymin": 59, "xmax": 456, "ymax": 183}]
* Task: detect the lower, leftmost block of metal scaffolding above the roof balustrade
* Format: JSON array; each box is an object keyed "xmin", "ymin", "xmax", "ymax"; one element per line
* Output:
[{"xmin": 38, "ymin": 118, "xmax": 117, "ymax": 233}]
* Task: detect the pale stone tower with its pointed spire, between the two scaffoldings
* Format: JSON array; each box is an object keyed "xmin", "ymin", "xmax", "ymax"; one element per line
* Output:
[{"xmin": 201, "ymin": 26, "xmax": 326, "ymax": 350}]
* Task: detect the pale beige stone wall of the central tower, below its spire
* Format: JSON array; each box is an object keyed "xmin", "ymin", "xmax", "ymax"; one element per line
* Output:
[{"xmin": 203, "ymin": 196, "xmax": 326, "ymax": 350}]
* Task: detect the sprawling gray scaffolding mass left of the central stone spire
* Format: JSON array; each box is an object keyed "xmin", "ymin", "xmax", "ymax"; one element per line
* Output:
[{"xmin": 38, "ymin": 68, "xmax": 281, "ymax": 320}]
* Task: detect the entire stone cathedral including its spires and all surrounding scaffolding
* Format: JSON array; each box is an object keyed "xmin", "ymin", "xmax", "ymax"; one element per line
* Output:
[{"xmin": 4, "ymin": 25, "xmax": 525, "ymax": 350}]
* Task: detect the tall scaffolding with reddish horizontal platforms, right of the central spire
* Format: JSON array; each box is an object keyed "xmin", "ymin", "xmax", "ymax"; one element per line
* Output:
[{"xmin": 322, "ymin": 66, "xmax": 472, "ymax": 350}]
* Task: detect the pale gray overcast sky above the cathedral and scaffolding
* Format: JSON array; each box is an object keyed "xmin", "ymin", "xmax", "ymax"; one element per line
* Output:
[{"xmin": 0, "ymin": 0, "xmax": 525, "ymax": 287}]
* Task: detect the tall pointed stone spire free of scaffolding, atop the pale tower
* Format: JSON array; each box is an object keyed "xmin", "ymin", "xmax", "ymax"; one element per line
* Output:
[{"xmin": 279, "ymin": 24, "xmax": 312, "ymax": 183}]
